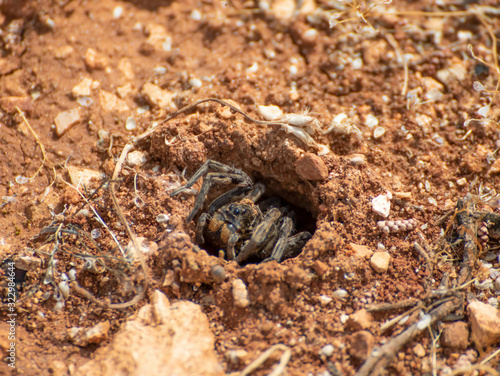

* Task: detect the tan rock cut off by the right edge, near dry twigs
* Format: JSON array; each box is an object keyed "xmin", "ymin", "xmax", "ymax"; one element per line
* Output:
[{"xmin": 468, "ymin": 301, "xmax": 500, "ymax": 346}]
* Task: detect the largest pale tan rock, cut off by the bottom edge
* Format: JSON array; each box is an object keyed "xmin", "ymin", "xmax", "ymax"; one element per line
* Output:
[{"xmin": 75, "ymin": 290, "xmax": 225, "ymax": 376}]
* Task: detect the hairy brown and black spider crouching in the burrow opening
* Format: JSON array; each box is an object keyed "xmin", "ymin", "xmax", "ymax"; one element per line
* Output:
[{"xmin": 170, "ymin": 160, "xmax": 311, "ymax": 264}]
